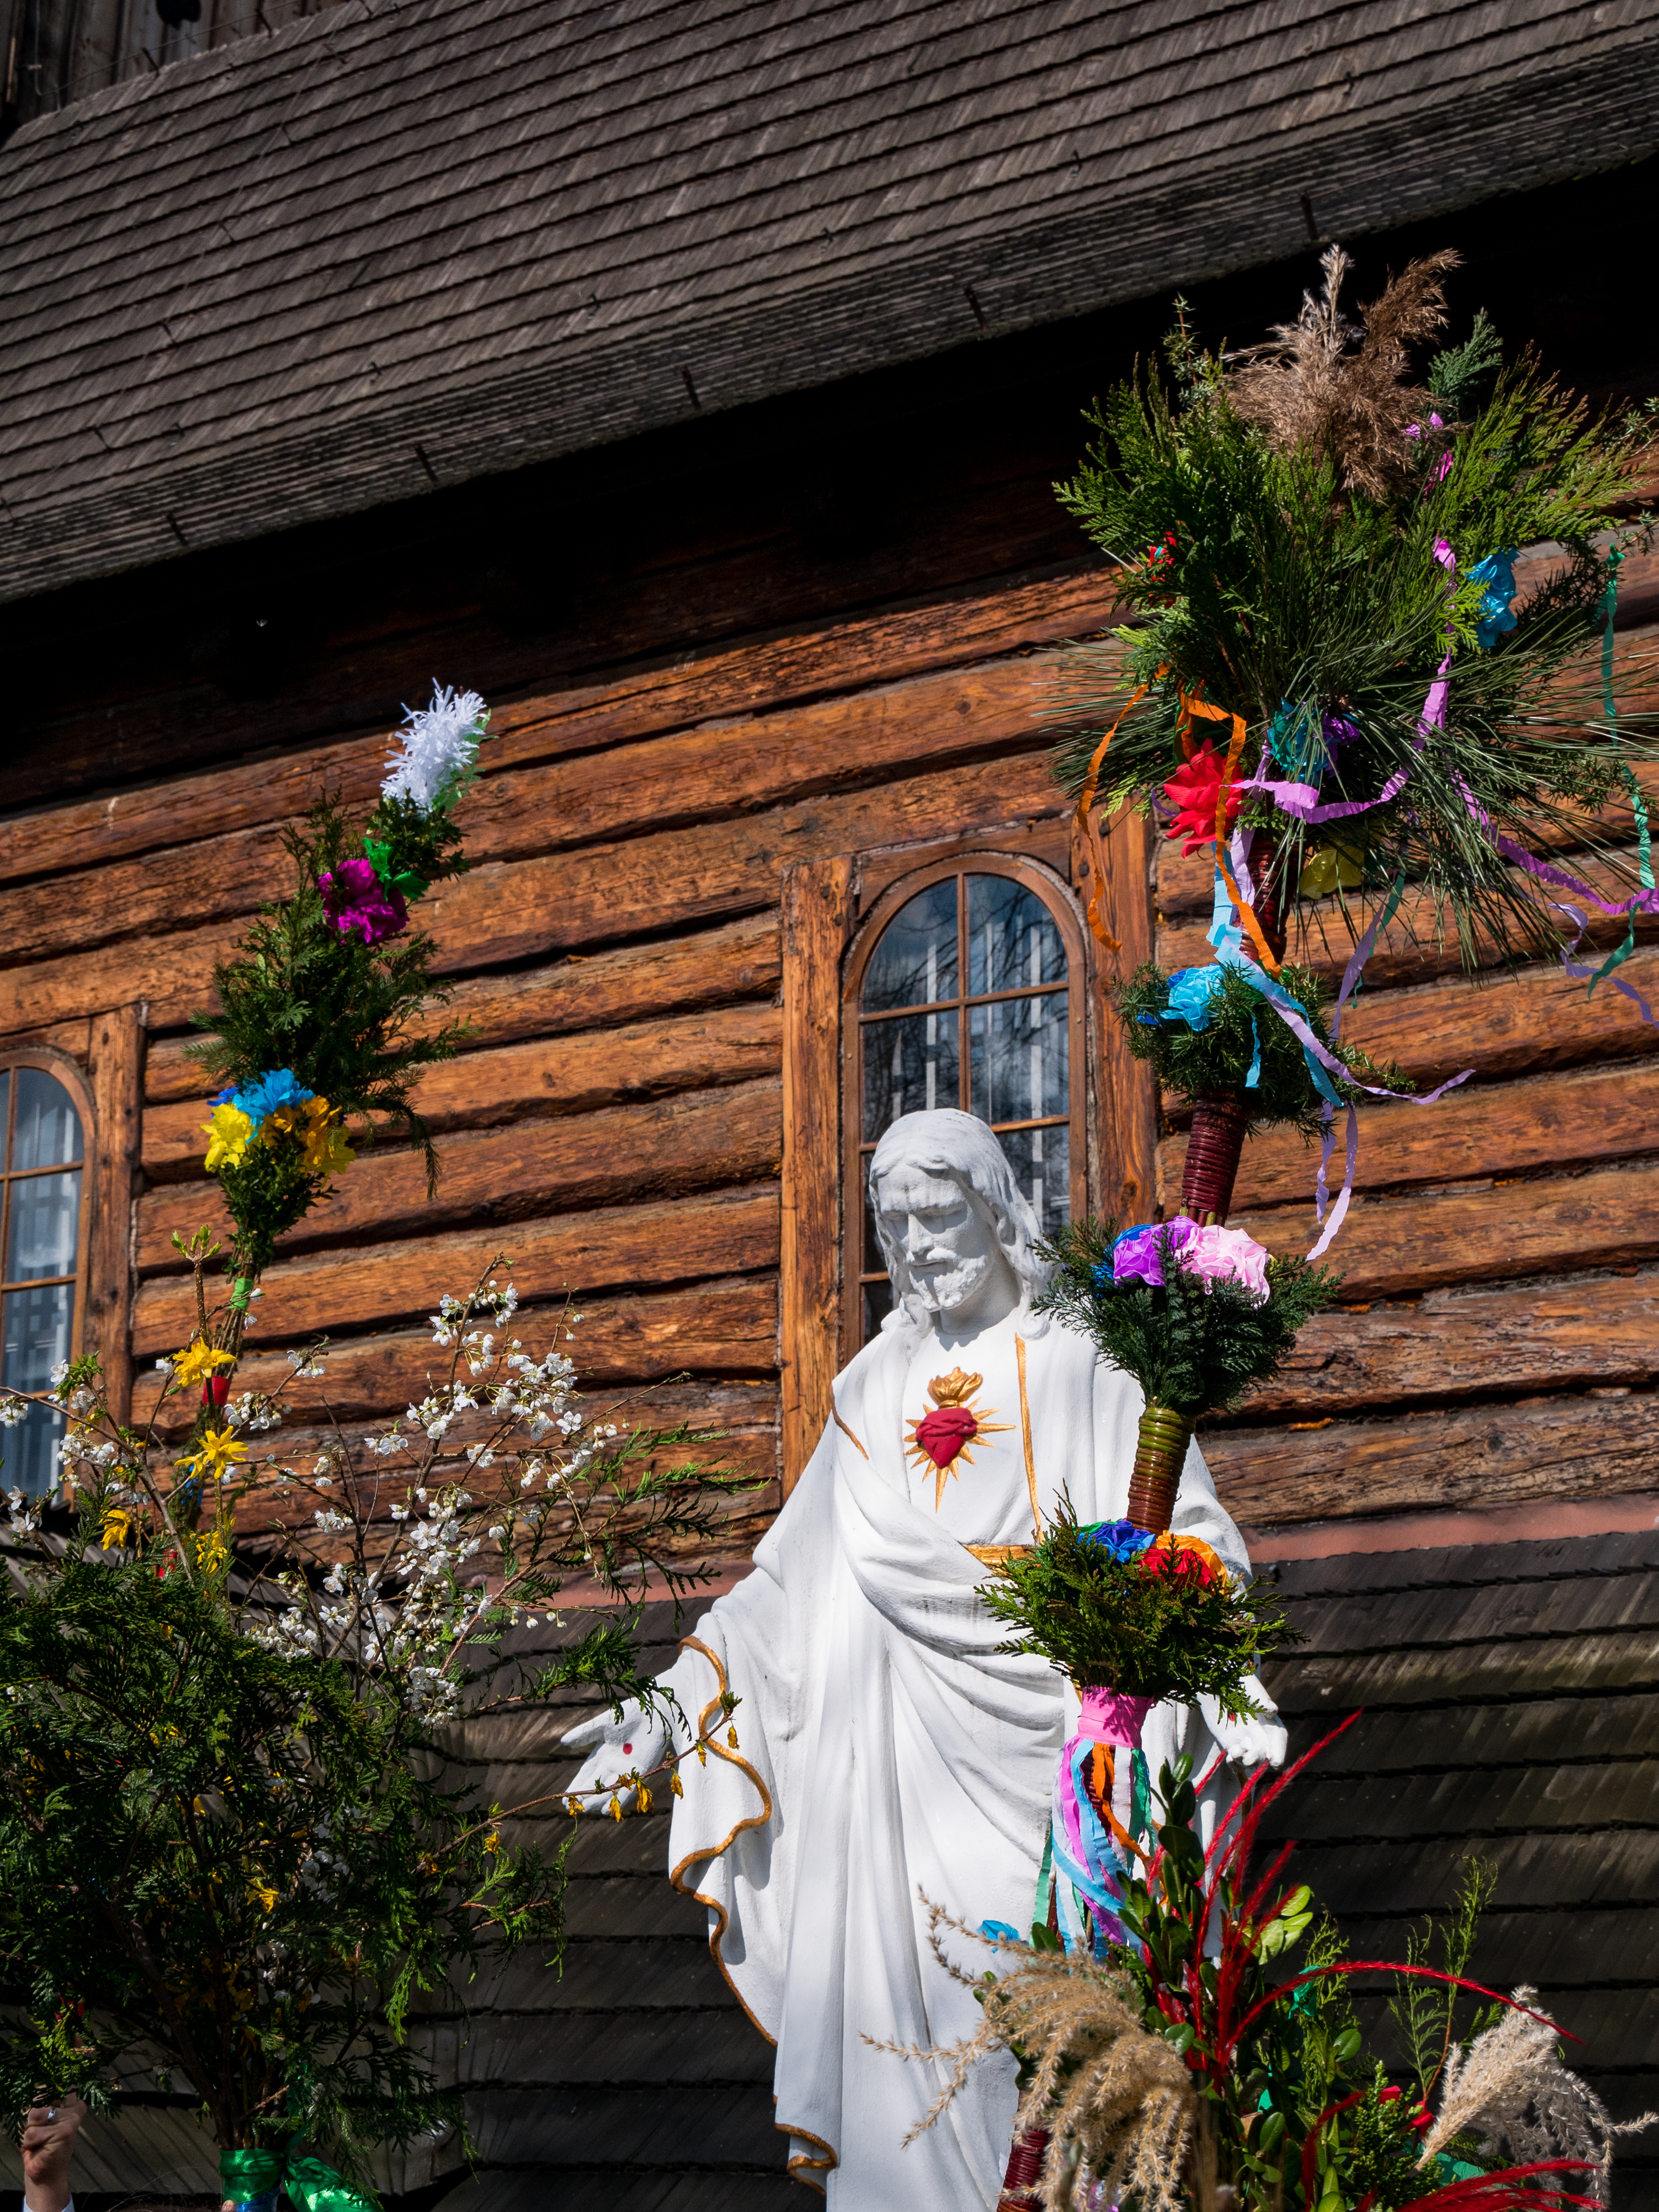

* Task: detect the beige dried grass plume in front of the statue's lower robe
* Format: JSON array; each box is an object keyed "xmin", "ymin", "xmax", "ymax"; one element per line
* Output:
[{"xmin": 865, "ymin": 1896, "xmax": 1197, "ymax": 2212}]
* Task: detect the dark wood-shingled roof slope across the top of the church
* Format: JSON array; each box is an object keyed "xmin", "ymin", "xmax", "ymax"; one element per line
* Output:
[{"xmin": 0, "ymin": 0, "xmax": 1659, "ymax": 597}]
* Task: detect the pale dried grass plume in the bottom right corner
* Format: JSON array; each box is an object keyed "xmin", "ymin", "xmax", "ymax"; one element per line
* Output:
[{"xmin": 1418, "ymin": 1988, "xmax": 1659, "ymax": 2203}]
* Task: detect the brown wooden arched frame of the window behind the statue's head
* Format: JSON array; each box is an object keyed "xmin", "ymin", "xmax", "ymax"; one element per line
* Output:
[{"xmin": 841, "ymin": 847, "xmax": 1091, "ymax": 1358}]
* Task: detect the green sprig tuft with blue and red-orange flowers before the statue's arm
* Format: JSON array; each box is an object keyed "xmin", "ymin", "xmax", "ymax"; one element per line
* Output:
[{"xmin": 982, "ymin": 1500, "xmax": 1301, "ymax": 1716}]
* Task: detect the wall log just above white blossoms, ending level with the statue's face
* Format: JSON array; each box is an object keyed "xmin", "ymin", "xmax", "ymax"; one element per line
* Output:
[{"xmin": 132, "ymin": 1181, "xmax": 779, "ymax": 1358}]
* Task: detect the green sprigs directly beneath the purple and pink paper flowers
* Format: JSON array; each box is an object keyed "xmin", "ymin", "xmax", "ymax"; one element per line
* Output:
[{"xmin": 1035, "ymin": 1221, "xmax": 1341, "ymax": 1420}]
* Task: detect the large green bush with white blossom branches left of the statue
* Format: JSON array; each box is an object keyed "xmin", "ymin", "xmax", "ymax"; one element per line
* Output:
[{"xmin": 0, "ymin": 1265, "xmax": 754, "ymax": 2172}]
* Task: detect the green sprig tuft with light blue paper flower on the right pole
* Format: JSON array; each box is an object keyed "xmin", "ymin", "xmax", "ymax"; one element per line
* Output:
[{"xmin": 1113, "ymin": 960, "xmax": 1413, "ymax": 1137}]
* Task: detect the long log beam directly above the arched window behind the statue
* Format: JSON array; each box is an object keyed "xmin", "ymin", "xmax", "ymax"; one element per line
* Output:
[{"xmin": 0, "ymin": 739, "xmax": 1064, "ymax": 1035}]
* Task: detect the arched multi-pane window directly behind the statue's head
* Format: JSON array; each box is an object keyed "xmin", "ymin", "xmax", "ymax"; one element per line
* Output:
[{"xmin": 845, "ymin": 854, "xmax": 1086, "ymax": 1352}]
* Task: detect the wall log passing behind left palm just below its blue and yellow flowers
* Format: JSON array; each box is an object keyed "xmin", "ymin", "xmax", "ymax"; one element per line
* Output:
[{"xmin": 137, "ymin": 1077, "xmax": 783, "ymax": 1270}]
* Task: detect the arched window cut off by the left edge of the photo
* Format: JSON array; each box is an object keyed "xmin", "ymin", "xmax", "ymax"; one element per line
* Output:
[{"xmin": 0, "ymin": 1062, "xmax": 86, "ymax": 1495}]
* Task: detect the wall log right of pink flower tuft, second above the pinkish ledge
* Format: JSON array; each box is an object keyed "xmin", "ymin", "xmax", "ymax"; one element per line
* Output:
[{"xmin": 1236, "ymin": 1274, "xmax": 1659, "ymax": 1427}]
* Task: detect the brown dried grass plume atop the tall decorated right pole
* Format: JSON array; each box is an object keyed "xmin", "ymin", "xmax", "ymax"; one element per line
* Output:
[{"xmin": 1227, "ymin": 246, "xmax": 1460, "ymax": 500}]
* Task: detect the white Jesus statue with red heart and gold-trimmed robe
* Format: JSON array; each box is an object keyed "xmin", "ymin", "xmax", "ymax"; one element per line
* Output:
[{"xmin": 566, "ymin": 1113, "xmax": 1285, "ymax": 2212}]
